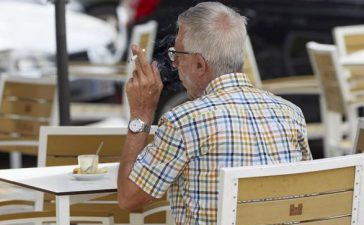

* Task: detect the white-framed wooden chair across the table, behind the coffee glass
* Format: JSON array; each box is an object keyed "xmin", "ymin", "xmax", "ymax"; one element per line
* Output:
[{"xmin": 36, "ymin": 126, "xmax": 171, "ymax": 225}]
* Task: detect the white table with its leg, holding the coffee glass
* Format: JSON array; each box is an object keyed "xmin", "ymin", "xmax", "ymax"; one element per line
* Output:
[{"xmin": 0, "ymin": 163, "xmax": 119, "ymax": 225}]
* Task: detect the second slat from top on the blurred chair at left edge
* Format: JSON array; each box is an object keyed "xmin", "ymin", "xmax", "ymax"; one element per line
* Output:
[{"xmin": 0, "ymin": 99, "xmax": 53, "ymax": 118}]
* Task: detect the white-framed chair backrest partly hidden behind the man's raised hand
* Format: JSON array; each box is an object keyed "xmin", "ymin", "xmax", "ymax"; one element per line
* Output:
[{"xmin": 123, "ymin": 20, "xmax": 158, "ymax": 121}]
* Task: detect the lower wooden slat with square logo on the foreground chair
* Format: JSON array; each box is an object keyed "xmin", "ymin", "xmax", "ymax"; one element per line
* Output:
[{"xmin": 237, "ymin": 192, "xmax": 353, "ymax": 225}]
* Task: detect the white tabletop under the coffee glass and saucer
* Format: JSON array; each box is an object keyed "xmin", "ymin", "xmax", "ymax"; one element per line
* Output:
[{"xmin": 0, "ymin": 163, "xmax": 119, "ymax": 195}]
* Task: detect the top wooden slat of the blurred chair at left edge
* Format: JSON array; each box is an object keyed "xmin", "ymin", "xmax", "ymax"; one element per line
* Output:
[{"xmin": 4, "ymin": 81, "xmax": 56, "ymax": 101}]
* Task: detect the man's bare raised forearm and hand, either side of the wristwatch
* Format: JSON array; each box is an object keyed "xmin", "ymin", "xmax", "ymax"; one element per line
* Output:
[{"xmin": 118, "ymin": 45, "xmax": 163, "ymax": 210}]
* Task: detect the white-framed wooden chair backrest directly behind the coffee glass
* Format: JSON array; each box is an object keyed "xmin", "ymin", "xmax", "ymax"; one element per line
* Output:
[{"xmin": 38, "ymin": 126, "xmax": 134, "ymax": 167}]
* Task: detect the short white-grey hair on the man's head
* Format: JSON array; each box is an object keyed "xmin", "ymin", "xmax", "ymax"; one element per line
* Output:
[{"xmin": 177, "ymin": 2, "xmax": 247, "ymax": 76}]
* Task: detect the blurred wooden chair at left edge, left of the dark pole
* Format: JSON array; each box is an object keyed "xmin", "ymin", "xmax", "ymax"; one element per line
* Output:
[{"xmin": 0, "ymin": 76, "xmax": 58, "ymax": 168}]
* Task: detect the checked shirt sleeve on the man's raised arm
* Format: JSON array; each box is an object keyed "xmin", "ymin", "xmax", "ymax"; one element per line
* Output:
[{"xmin": 129, "ymin": 120, "xmax": 188, "ymax": 198}]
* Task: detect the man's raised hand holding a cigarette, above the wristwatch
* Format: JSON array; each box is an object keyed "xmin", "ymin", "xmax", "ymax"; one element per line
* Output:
[{"xmin": 126, "ymin": 45, "xmax": 163, "ymax": 124}]
